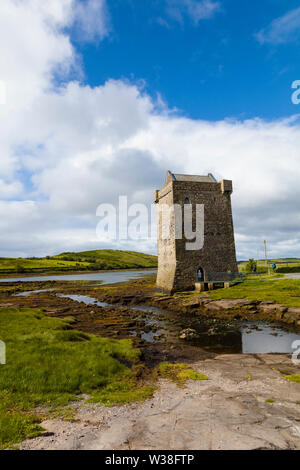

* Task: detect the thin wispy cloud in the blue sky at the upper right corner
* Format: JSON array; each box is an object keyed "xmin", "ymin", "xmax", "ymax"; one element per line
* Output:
[{"xmin": 255, "ymin": 8, "xmax": 300, "ymax": 44}]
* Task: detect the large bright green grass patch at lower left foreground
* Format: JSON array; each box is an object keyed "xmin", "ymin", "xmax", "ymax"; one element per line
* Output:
[{"xmin": 0, "ymin": 308, "xmax": 153, "ymax": 448}]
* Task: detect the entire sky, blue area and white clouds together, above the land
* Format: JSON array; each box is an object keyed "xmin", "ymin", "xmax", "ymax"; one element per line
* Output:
[{"xmin": 0, "ymin": 0, "xmax": 300, "ymax": 259}]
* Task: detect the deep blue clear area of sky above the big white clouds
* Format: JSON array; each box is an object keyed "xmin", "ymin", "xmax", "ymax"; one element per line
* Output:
[{"xmin": 76, "ymin": 0, "xmax": 300, "ymax": 120}]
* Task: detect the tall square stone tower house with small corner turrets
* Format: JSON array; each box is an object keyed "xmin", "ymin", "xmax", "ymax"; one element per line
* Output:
[{"xmin": 155, "ymin": 171, "xmax": 238, "ymax": 293}]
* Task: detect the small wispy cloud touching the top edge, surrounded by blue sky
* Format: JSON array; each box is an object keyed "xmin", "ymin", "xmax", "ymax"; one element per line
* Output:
[{"xmin": 167, "ymin": 0, "xmax": 220, "ymax": 24}]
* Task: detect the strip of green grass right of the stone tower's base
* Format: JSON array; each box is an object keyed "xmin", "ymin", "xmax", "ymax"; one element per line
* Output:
[{"xmin": 209, "ymin": 276, "xmax": 300, "ymax": 307}]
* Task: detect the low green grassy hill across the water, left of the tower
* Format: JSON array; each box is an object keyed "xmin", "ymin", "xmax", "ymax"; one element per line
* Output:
[{"xmin": 0, "ymin": 250, "xmax": 157, "ymax": 274}]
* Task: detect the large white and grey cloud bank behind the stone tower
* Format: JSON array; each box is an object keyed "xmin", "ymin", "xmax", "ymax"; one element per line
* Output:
[{"xmin": 0, "ymin": 0, "xmax": 300, "ymax": 258}]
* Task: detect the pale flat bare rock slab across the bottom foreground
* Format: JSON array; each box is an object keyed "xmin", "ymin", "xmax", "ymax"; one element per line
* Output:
[{"xmin": 21, "ymin": 354, "xmax": 300, "ymax": 450}]
